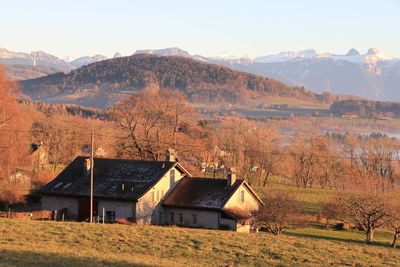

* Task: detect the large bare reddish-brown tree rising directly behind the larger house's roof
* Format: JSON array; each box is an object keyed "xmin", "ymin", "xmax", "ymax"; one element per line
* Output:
[{"xmin": 112, "ymin": 90, "xmax": 193, "ymax": 160}]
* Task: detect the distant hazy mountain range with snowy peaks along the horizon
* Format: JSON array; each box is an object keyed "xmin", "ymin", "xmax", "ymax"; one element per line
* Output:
[{"xmin": 0, "ymin": 47, "xmax": 400, "ymax": 101}]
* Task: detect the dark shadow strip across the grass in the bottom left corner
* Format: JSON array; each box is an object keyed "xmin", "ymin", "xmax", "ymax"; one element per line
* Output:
[{"xmin": 0, "ymin": 250, "xmax": 154, "ymax": 267}]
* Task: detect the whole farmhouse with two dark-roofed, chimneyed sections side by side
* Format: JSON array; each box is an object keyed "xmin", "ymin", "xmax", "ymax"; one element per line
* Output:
[{"xmin": 39, "ymin": 149, "xmax": 262, "ymax": 230}]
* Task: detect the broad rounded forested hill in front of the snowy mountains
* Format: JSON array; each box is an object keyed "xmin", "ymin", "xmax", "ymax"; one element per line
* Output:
[{"xmin": 21, "ymin": 54, "xmax": 332, "ymax": 106}]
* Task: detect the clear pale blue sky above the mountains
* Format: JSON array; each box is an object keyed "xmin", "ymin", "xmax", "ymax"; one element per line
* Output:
[{"xmin": 0, "ymin": 0, "xmax": 400, "ymax": 59}]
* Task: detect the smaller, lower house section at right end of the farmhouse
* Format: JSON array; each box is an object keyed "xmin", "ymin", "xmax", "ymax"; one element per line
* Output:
[{"xmin": 162, "ymin": 169, "xmax": 263, "ymax": 232}]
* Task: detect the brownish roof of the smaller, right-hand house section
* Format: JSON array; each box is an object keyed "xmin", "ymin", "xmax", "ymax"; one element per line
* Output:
[{"xmin": 163, "ymin": 177, "xmax": 244, "ymax": 210}]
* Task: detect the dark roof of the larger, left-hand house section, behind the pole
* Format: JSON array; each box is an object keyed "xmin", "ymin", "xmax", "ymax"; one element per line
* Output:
[{"xmin": 39, "ymin": 157, "xmax": 185, "ymax": 201}]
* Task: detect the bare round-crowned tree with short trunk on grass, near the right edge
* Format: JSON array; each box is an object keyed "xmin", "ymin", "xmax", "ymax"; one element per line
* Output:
[{"xmin": 342, "ymin": 193, "xmax": 390, "ymax": 243}]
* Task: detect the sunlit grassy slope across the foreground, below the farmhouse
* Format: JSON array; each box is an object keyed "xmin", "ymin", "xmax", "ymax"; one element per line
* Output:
[{"xmin": 0, "ymin": 219, "xmax": 400, "ymax": 266}]
